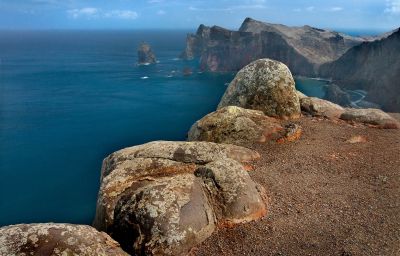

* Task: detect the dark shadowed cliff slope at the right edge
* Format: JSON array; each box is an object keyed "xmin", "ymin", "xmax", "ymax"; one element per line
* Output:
[{"xmin": 319, "ymin": 29, "xmax": 400, "ymax": 112}]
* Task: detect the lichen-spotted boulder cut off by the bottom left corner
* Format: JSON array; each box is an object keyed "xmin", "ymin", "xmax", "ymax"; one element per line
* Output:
[{"xmin": 0, "ymin": 223, "xmax": 128, "ymax": 256}]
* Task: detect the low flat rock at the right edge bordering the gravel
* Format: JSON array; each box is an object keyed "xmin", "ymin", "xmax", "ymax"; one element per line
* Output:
[{"xmin": 340, "ymin": 108, "xmax": 400, "ymax": 129}]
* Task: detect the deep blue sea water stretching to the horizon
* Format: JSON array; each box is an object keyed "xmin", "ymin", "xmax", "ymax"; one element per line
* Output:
[{"xmin": 0, "ymin": 31, "xmax": 326, "ymax": 226}]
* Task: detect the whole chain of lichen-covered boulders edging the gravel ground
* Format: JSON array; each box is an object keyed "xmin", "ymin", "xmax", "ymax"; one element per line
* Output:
[{"xmin": 0, "ymin": 59, "xmax": 400, "ymax": 255}]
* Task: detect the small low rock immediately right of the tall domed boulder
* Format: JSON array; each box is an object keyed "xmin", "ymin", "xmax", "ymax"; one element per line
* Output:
[{"xmin": 300, "ymin": 97, "xmax": 345, "ymax": 119}]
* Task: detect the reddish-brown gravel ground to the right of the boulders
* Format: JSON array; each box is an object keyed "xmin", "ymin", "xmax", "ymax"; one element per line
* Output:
[{"xmin": 195, "ymin": 114, "xmax": 400, "ymax": 256}]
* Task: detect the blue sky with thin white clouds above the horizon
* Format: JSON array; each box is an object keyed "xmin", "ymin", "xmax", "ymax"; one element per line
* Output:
[{"xmin": 0, "ymin": 0, "xmax": 400, "ymax": 30}]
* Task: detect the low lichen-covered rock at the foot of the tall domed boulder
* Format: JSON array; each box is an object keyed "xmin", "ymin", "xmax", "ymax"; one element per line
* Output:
[{"xmin": 188, "ymin": 106, "xmax": 283, "ymax": 145}]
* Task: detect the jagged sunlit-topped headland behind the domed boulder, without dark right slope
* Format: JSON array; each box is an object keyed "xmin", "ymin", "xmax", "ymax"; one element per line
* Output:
[{"xmin": 182, "ymin": 18, "xmax": 364, "ymax": 76}]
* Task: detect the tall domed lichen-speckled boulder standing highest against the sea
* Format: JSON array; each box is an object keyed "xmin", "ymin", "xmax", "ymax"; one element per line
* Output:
[{"xmin": 218, "ymin": 59, "xmax": 301, "ymax": 119}]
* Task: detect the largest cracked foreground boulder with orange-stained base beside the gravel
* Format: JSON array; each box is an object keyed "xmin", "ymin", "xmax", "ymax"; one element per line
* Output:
[{"xmin": 94, "ymin": 141, "xmax": 266, "ymax": 255}]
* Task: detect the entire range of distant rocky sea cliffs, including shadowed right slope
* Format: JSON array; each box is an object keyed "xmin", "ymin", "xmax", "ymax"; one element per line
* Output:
[{"xmin": 181, "ymin": 18, "xmax": 400, "ymax": 112}]
